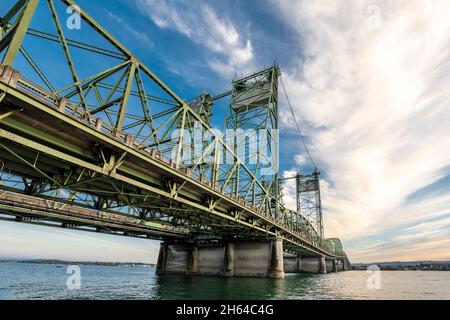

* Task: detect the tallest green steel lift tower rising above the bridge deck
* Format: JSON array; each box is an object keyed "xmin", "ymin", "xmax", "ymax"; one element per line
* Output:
[{"xmin": 225, "ymin": 66, "xmax": 280, "ymax": 218}]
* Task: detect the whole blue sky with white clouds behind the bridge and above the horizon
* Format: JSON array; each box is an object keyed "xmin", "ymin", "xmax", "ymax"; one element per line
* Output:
[{"xmin": 0, "ymin": 0, "xmax": 450, "ymax": 262}]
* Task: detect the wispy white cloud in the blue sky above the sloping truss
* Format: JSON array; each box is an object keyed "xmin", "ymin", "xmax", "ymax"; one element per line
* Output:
[{"xmin": 136, "ymin": 0, "xmax": 254, "ymax": 79}]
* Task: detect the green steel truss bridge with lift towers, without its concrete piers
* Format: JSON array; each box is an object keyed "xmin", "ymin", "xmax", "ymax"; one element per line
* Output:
[{"xmin": 0, "ymin": 0, "xmax": 346, "ymax": 259}]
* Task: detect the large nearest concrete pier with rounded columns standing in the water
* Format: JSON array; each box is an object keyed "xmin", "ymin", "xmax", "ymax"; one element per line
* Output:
[{"xmin": 157, "ymin": 239, "xmax": 284, "ymax": 278}]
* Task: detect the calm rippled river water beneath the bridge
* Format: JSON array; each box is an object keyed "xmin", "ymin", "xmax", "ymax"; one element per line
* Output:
[{"xmin": 0, "ymin": 262, "xmax": 450, "ymax": 299}]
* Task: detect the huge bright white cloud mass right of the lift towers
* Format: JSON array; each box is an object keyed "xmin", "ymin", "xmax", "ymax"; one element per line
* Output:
[{"xmin": 278, "ymin": 0, "xmax": 450, "ymax": 257}]
